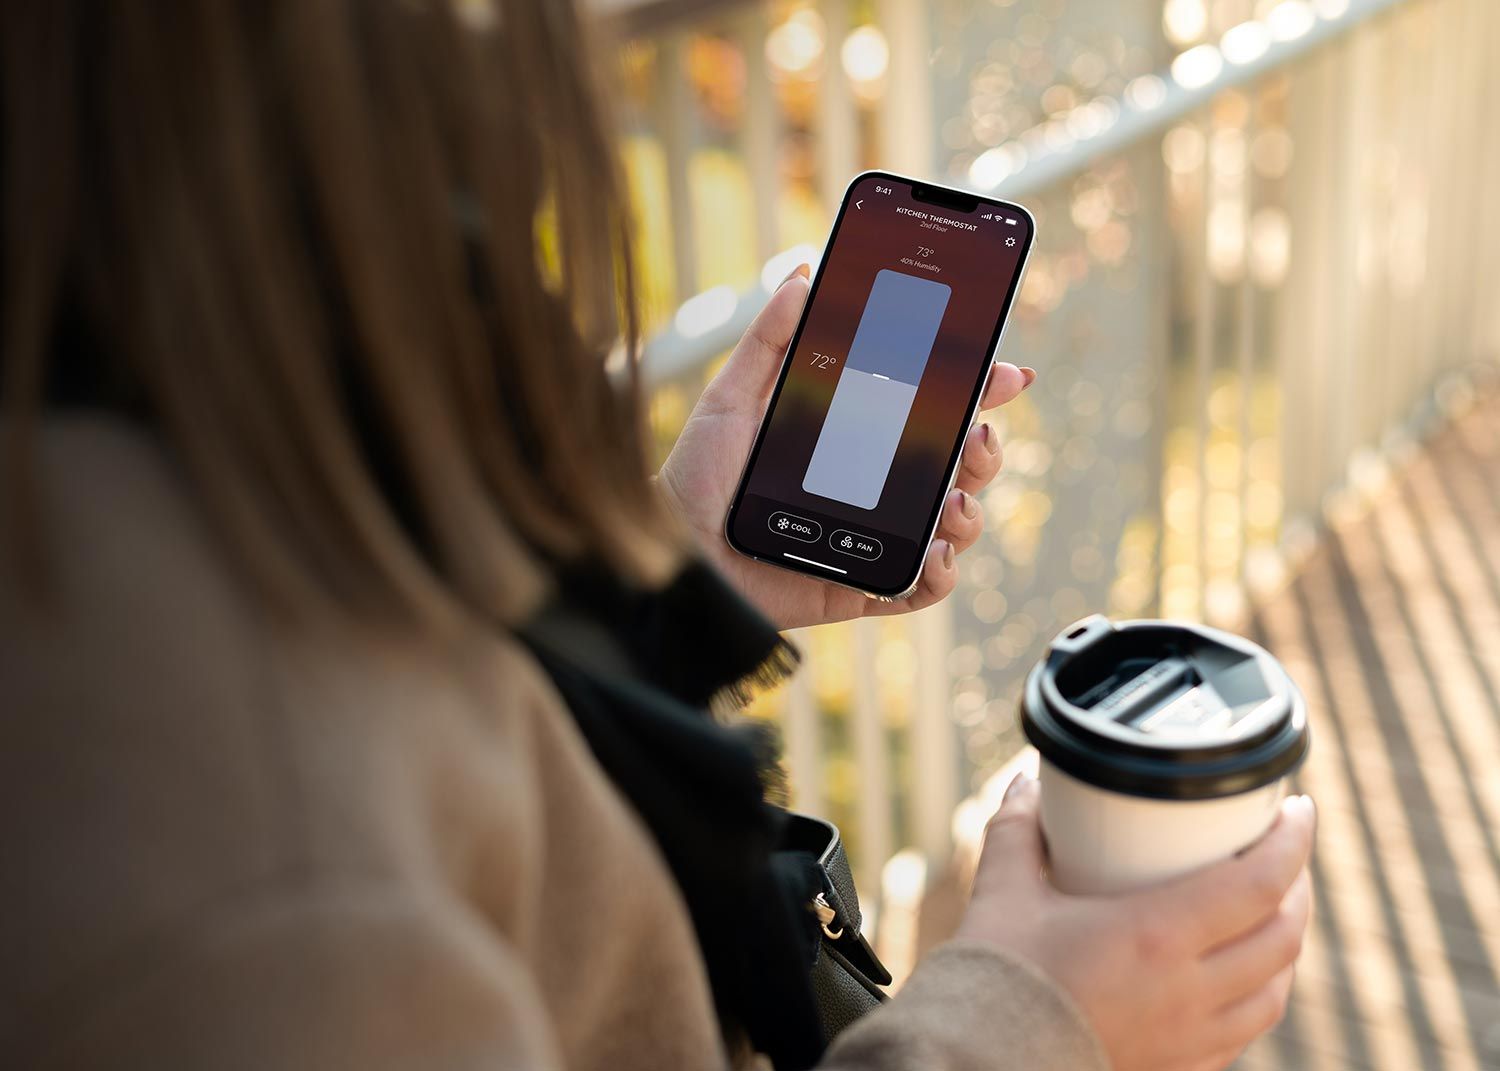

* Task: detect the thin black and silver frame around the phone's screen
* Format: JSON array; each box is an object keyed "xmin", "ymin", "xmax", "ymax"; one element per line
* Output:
[{"xmin": 725, "ymin": 171, "xmax": 1037, "ymax": 602}]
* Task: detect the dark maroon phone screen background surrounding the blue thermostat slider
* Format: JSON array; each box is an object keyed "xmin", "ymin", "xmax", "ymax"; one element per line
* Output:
[{"xmin": 731, "ymin": 176, "xmax": 1031, "ymax": 591}]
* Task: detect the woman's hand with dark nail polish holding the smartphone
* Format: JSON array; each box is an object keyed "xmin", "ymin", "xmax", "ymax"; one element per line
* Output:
[{"xmin": 660, "ymin": 264, "xmax": 1037, "ymax": 629}]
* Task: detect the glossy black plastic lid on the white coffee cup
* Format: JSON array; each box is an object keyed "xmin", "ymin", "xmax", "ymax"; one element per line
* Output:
[{"xmin": 1020, "ymin": 615, "xmax": 1308, "ymax": 800}]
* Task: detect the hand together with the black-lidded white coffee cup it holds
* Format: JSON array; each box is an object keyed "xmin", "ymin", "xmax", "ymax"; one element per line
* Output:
[{"xmin": 959, "ymin": 618, "xmax": 1316, "ymax": 1071}]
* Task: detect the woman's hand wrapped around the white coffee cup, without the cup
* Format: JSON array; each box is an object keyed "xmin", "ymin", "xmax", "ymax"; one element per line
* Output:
[{"xmin": 959, "ymin": 779, "xmax": 1316, "ymax": 1071}]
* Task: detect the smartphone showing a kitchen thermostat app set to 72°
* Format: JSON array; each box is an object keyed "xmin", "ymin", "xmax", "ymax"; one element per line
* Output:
[{"xmin": 725, "ymin": 171, "xmax": 1037, "ymax": 599}]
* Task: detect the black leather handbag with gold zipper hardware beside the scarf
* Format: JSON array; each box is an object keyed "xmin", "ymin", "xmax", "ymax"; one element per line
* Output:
[{"xmin": 782, "ymin": 812, "xmax": 891, "ymax": 1041}]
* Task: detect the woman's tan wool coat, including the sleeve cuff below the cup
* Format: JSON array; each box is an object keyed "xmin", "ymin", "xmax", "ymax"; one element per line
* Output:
[{"xmin": 0, "ymin": 419, "xmax": 1106, "ymax": 1071}]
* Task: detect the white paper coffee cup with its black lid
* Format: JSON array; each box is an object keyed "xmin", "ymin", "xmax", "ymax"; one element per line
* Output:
[{"xmin": 1020, "ymin": 615, "xmax": 1310, "ymax": 894}]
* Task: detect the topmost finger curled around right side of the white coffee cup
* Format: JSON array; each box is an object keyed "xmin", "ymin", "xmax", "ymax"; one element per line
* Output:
[{"xmin": 1140, "ymin": 797, "xmax": 1317, "ymax": 953}]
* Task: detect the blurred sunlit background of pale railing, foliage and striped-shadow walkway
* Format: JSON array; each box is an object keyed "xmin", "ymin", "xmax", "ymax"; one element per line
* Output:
[{"xmin": 596, "ymin": 0, "xmax": 1500, "ymax": 1071}]
